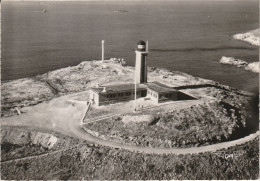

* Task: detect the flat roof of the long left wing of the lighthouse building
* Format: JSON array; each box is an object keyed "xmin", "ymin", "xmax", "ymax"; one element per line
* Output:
[{"xmin": 91, "ymin": 83, "xmax": 147, "ymax": 94}]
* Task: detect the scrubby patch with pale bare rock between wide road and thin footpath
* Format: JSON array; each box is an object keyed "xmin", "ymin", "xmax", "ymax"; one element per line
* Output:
[{"xmin": 1, "ymin": 126, "xmax": 79, "ymax": 161}]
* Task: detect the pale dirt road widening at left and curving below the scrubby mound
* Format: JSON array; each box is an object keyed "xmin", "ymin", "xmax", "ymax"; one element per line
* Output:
[{"xmin": 1, "ymin": 94, "xmax": 259, "ymax": 154}]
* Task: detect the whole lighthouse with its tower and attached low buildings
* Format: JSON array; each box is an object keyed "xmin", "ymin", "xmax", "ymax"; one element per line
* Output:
[{"xmin": 89, "ymin": 40, "xmax": 179, "ymax": 106}]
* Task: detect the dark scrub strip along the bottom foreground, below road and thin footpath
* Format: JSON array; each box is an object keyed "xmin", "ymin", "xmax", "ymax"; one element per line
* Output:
[{"xmin": 1, "ymin": 135, "xmax": 259, "ymax": 180}]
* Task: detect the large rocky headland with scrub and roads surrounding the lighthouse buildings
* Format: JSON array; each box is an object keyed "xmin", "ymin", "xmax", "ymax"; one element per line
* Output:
[{"xmin": 1, "ymin": 55, "xmax": 259, "ymax": 180}]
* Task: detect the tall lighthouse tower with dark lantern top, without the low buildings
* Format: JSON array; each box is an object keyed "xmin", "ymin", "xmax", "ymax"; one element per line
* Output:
[{"xmin": 135, "ymin": 40, "xmax": 148, "ymax": 84}]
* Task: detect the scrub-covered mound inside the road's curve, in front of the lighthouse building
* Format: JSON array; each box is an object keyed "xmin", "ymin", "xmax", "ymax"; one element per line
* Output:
[{"xmin": 85, "ymin": 101, "xmax": 249, "ymax": 148}]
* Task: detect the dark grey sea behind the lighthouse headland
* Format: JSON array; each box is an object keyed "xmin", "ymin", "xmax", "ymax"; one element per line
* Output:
[{"xmin": 1, "ymin": 0, "xmax": 259, "ymax": 90}]
